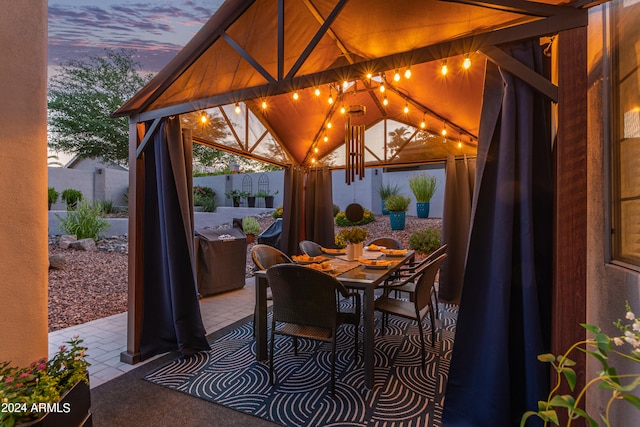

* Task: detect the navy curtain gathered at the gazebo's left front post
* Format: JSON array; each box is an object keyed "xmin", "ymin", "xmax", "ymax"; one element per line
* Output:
[{"xmin": 140, "ymin": 116, "xmax": 209, "ymax": 358}]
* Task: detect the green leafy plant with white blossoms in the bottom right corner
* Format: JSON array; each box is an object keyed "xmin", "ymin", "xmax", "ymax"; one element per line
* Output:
[{"xmin": 520, "ymin": 302, "xmax": 640, "ymax": 427}]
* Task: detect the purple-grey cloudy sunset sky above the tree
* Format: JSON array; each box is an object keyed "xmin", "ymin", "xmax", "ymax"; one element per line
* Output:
[{"xmin": 49, "ymin": 0, "xmax": 223, "ymax": 72}]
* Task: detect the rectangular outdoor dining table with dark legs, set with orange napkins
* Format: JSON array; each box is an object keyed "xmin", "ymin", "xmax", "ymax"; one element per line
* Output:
[{"xmin": 254, "ymin": 250, "xmax": 415, "ymax": 389}]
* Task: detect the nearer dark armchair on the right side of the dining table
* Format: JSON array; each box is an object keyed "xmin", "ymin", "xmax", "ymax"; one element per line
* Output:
[{"xmin": 374, "ymin": 254, "xmax": 447, "ymax": 370}]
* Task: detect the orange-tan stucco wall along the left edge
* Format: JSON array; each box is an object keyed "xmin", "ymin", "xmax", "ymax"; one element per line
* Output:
[{"xmin": 0, "ymin": 0, "xmax": 48, "ymax": 365}]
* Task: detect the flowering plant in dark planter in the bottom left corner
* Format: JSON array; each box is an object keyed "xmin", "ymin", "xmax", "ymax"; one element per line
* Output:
[{"xmin": 0, "ymin": 336, "xmax": 91, "ymax": 427}]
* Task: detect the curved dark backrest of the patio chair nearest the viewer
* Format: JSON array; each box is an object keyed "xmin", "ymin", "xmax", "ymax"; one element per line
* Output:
[{"xmin": 267, "ymin": 264, "xmax": 346, "ymax": 328}]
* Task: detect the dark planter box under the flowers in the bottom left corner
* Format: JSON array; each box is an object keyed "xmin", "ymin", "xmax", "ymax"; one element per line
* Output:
[{"xmin": 18, "ymin": 381, "xmax": 93, "ymax": 427}]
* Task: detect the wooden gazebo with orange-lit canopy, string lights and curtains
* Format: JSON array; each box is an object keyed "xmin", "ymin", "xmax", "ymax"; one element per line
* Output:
[{"xmin": 113, "ymin": 0, "xmax": 590, "ymax": 425}]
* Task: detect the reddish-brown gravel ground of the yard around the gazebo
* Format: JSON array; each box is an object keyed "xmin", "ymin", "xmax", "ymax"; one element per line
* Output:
[{"xmin": 49, "ymin": 215, "xmax": 441, "ymax": 332}]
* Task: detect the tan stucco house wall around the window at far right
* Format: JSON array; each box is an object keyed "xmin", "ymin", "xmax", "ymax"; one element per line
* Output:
[{"xmin": 586, "ymin": 6, "xmax": 640, "ymax": 426}]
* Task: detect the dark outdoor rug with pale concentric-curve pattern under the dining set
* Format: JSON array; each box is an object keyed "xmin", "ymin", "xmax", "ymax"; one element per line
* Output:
[{"xmin": 145, "ymin": 305, "xmax": 457, "ymax": 426}]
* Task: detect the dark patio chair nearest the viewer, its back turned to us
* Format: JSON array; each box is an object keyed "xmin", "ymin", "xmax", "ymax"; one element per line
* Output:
[{"xmin": 267, "ymin": 264, "xmax": 360, "ymax": 397}]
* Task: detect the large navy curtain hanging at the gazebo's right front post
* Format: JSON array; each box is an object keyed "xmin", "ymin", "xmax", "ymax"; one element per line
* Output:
[{"xmin": 443, "ymin": 40, "xmax": 553, "ymax": 427}]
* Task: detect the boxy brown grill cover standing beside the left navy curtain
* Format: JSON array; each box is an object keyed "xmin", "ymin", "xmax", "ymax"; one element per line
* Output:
[{"xmin": 196, "ymin": 228, "xmax": 247, "ymax": 295}]
